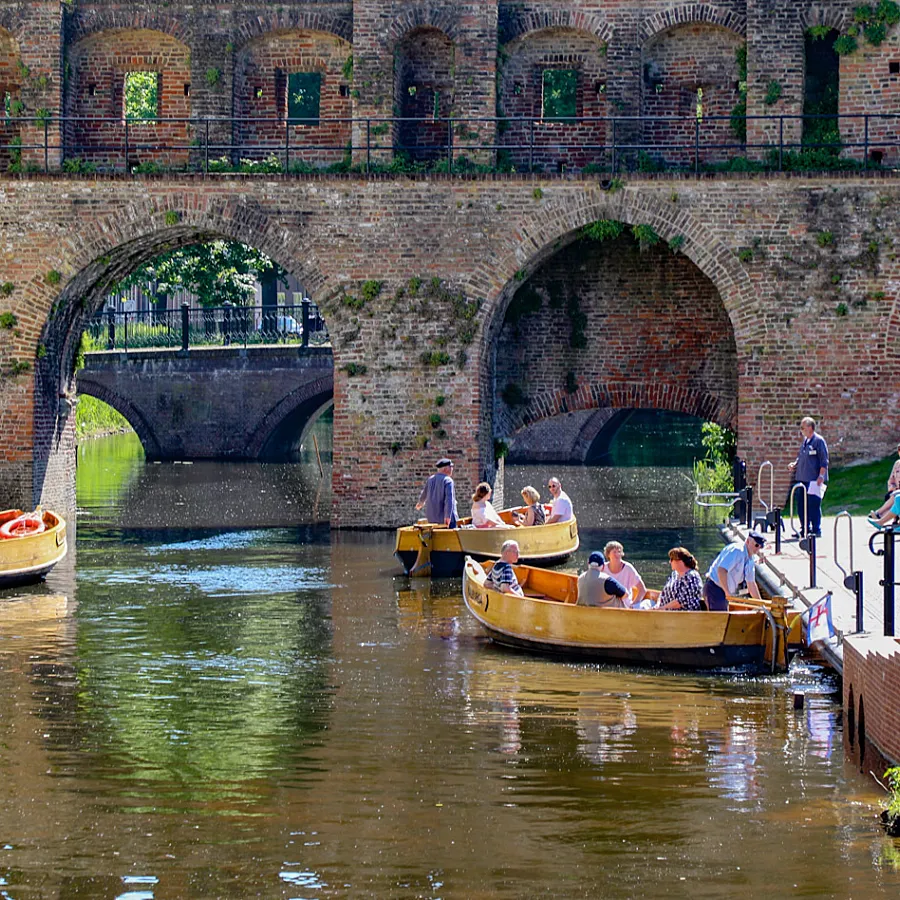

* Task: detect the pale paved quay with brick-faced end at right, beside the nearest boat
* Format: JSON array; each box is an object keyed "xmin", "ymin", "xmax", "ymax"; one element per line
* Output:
[{"xmin": 723, "ymin": 516, "xmax": 900, "ymax": 768}]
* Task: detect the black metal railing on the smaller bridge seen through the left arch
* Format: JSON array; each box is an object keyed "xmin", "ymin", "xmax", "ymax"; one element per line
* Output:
[{"xmin": 85, "ymin": 301, "xmax": 330, "ymax": 352}]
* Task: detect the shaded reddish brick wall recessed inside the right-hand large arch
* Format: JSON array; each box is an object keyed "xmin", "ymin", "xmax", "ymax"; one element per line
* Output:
[{"xmin": 495, "ymin": 234, "xmax": 737, "ymax": 434}]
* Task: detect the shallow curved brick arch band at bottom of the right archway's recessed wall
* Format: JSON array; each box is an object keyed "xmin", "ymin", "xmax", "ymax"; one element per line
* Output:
[{"xmin": 515, "ymin": 382, "xmax": 737, "ymax": 430}]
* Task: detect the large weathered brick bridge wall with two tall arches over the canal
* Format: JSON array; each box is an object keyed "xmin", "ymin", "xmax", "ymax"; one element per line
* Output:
[{"xmin": 0, "ymin": 175, "xmax": 900, "ymax": 526}]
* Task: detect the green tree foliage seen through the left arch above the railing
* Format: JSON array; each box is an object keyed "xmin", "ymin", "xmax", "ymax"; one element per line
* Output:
[{"xmin": 110, "ymin": 241, "xmax": 284, "ymax": 306}]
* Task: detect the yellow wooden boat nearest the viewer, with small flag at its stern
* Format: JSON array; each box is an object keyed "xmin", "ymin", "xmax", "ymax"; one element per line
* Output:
[{"xmin": 463, "ymin": 558, "xmax": 799, "ymax": 671}]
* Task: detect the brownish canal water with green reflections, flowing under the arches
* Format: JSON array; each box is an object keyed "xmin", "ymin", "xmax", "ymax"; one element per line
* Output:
[{"xmin": 0, "ymin": 436, "xmax": 900, "ymax": 900}]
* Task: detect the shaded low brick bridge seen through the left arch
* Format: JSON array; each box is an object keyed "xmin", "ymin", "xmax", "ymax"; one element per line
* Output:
[{"xmin": 77, "ymin": 347, "xmax": 334, "ymax": 460}]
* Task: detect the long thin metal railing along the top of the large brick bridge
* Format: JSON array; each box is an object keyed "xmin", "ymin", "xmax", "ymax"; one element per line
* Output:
[{"xmin": 0, "ymin": 112, "xmax": 900, "ymax": 175}]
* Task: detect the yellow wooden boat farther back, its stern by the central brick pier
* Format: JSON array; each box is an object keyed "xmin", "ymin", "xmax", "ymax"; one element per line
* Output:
[{"xmin": 394, "ymin": 509, "xmax": 578, "ymax": 578}]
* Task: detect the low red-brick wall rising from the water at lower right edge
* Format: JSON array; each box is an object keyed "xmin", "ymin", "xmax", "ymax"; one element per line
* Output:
[{"xmin": 843, "ymin": 635, "xmax": 900, "ymax": 776}]
